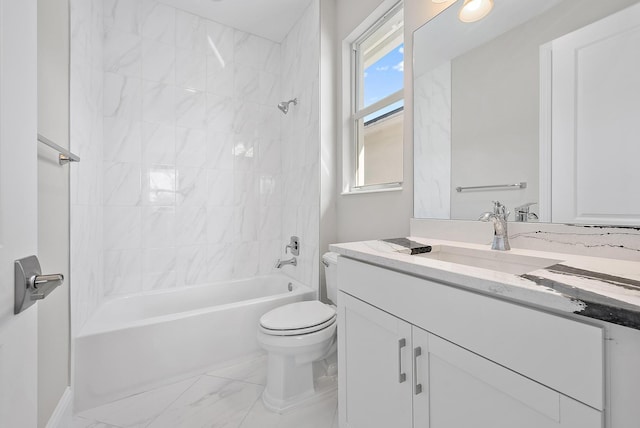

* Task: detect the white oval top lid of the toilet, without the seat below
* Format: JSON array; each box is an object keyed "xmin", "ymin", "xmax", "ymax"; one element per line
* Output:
[{"xmin": 260, "ymin": 300, "xmax": 336, "ymax": 330}]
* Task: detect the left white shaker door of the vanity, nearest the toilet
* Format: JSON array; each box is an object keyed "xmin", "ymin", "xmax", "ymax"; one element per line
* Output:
[{"xmin": 338, "ymin": 293, "xmax": 413, "ymax": 428}]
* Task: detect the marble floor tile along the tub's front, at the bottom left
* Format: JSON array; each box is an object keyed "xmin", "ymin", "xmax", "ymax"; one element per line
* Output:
[{"xmin": 78, "ymin": 377, "xmax": 198, "ymax": 428}]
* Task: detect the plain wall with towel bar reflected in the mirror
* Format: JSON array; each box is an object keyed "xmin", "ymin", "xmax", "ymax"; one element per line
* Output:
[{"xmin": 448, "ymin": 25, "xmax": 548, "ymax": 220}]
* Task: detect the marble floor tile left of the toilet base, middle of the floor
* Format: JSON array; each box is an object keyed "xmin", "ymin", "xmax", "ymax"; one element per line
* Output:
[{"xmin": 148, "ymin": 375, "xmax": 263, "ymax": 428}]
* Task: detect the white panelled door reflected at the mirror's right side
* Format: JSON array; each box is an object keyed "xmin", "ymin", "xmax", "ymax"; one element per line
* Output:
[{"xmin": 551, "ymin": 4, "xmax": 640, "ymax": 225}]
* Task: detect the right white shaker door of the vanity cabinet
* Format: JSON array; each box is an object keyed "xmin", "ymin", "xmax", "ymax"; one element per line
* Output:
[{"xmin": 414, "ymin": 334, "xmax": 602, "ymax": 428}]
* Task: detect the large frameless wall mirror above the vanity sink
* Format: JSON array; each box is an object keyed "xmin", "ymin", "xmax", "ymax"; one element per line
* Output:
[{"xmin": 413, "ymin": 0, "xmax": 640, "ymax": 225}]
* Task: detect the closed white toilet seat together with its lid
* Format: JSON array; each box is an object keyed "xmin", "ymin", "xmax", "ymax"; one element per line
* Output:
[{"xmin": 260, "ymin": 300, "xmax": 337, "ymax": 336}]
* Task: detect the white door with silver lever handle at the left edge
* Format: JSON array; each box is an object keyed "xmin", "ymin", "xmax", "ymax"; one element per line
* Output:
[{"xmin": 0, "ymin": 0, "xmax": 37, "ymax": 428}]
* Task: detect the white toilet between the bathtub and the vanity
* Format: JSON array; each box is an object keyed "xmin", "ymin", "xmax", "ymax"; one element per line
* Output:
[{"xmin": 258, "ymin": 253, "xmax": 338, "ymax": 413}]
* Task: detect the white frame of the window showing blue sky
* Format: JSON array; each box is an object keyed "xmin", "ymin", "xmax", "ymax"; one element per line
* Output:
[{"xmin": 342, "ymin": 0, "xmax": 404, "ymax": 195}]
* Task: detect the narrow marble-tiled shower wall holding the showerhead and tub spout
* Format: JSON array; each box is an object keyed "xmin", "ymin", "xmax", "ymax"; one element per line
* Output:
[{"xmin": 276, "ymin": 0, "xmax": 320, "ymax": 288}]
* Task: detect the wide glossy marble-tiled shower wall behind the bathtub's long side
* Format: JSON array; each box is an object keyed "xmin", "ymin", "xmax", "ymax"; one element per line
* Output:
[{"xmin": 103, "ymin": 0, "xmax": 282, "ymax": 295}]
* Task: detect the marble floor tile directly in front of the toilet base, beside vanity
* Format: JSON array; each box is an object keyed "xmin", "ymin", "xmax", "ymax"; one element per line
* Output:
[{"xmin": 240, "ymin": 391, "xmax": 338, "ymax": 428}]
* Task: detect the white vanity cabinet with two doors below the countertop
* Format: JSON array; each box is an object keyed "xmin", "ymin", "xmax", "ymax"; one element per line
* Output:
[{"xmin": 338, "ymin": 258, "xmax": 604, "ymax": 428}]
